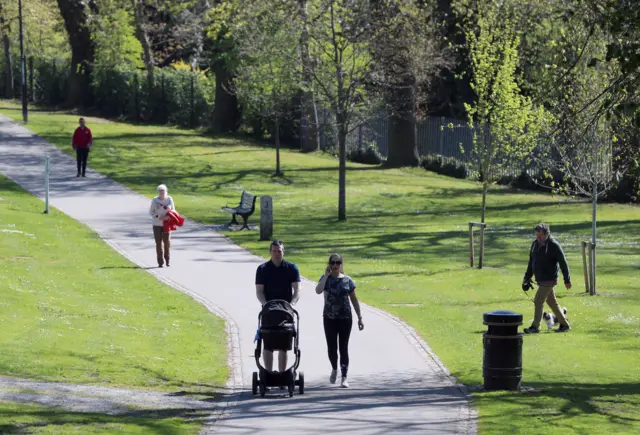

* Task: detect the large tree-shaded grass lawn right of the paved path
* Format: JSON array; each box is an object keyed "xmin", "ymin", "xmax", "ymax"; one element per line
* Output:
[{"xmin": 0, "ymin": 103, "xmax": 640, "ymax": 434}]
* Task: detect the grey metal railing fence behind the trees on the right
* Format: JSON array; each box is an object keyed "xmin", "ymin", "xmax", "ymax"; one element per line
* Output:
[{"xmin": 319, "ymin": 111, "xmax": 538, "ymax": 178}]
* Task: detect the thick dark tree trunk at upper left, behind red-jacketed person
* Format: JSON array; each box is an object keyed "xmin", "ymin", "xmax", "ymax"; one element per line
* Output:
[{"xmin": 58, "ymin": 0, "xmax": 97, "ymax": 107}]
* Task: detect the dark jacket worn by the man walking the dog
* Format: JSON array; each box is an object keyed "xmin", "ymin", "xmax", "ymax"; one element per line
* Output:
[{"xmin": 524, "ymin": 236, "xmax": 571, "ymax": 283}]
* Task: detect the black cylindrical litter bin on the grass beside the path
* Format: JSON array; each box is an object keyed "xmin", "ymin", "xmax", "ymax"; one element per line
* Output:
[{"xmin": 482, "ymin": 310, "xmax": 522, "ymax": 390}]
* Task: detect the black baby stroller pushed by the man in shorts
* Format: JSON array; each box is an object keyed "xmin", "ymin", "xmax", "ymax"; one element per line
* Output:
[{"xmin": 252, "ymin": 299, "xmax": 304, "ymax": 397}]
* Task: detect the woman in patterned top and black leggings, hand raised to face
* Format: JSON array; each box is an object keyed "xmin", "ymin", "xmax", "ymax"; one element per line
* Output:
[{"xmin": 316, "ymin": 254, "xmax": 364, "ymax": 388}]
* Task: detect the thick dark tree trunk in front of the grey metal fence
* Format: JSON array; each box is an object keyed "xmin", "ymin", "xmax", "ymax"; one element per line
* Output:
[{"xmin": 385, "ymin": 83, "xmax": 420, "ymax": 168}]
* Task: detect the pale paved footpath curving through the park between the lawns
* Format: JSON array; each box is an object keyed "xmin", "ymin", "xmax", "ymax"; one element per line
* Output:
[{"xmin": 0, "ymin": 115, "xmax": 476, "ymax": 435}]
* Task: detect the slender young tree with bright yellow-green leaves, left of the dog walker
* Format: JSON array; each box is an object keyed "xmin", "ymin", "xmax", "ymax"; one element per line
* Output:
[{"xmin": 458, "ymin": 1, "xmax": 548, "ymax": 223}]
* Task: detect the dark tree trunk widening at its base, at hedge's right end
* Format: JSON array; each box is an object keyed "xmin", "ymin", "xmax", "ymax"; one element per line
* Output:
[{"xmin": 211, "ymin": 60, "xmax": 240, "ymax": 133}]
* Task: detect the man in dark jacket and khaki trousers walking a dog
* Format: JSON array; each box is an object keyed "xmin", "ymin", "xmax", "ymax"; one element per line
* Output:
[{"xmin": 522, "ymin": 223, "xmax": 571, "ymax": 334}]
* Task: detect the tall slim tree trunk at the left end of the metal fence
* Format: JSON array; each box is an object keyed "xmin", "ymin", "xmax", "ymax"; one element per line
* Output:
[{"xmin": 298, "ymin": 0, "xmax": 320, "ymax": 152}]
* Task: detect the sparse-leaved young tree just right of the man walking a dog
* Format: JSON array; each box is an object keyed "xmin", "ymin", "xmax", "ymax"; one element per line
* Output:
[{"xmin": 537, "ymin": 23, "xmax": 631, "ymax": 290}]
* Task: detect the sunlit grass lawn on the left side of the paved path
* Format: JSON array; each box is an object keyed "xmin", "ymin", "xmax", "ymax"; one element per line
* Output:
[{"xmin": 0, "ymin": 173, "xmax": 227, "ymax": 433}]
